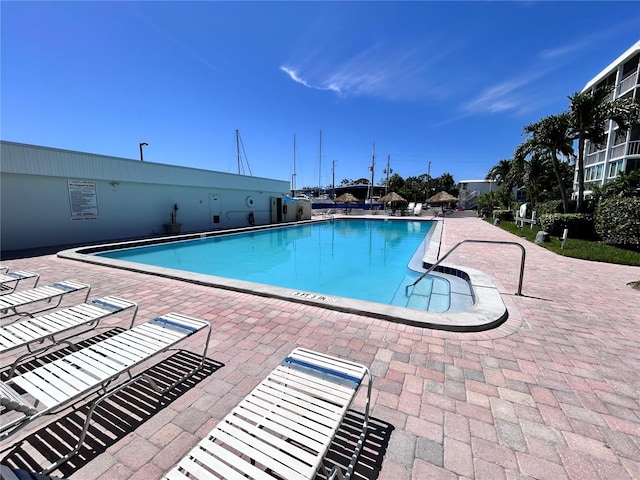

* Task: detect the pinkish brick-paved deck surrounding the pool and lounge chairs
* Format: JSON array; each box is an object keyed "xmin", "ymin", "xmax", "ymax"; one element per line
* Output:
[{"xmin": 2, "ymin": 215, "xmax": 640, "ymax": 480}]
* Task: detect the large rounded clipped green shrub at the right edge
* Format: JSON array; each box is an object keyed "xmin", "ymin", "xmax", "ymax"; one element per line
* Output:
[{"xmin": 595, "ymin": 197, "xmax": 640, "ymax": 245}]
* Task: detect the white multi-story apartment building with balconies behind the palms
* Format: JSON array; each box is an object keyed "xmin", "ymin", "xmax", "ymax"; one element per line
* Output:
[{"xmin": 574, "ymin": 41, "xmax": 640, "ymax": 195}]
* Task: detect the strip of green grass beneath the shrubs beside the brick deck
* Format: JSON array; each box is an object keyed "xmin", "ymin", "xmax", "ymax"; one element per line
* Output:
[{"xmin": 486, "ymin": 219, "xmax": 640, "ymax": 266}]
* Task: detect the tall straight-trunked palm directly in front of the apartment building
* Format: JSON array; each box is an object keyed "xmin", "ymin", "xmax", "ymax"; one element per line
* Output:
[{"xmin": 568, "ymin": 87, "xmax": 640, "ymax": 211}]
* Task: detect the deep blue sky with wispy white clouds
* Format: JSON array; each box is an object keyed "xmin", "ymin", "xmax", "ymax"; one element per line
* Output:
[{"xmin": 0, "ymin": 1, "xmax": 640, "ymax": 188}]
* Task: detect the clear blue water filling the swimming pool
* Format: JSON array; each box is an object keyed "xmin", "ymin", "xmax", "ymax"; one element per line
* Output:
[{"xmin": 98, "ymin": 219, "xmax": 460, "ymax": 312}]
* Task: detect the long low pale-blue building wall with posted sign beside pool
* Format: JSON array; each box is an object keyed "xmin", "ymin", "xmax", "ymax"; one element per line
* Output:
[{"xmin": 0, "ymin": 141, "xmax": 295, "ymax": 252}]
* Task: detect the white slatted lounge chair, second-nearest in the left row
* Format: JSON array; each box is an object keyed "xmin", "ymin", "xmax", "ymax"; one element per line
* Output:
[{"xmin": 0, "ymin": 296, "xmax": 138, "ymax": 378}]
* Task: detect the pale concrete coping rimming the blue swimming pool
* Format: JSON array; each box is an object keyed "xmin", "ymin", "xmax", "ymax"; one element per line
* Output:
[{"xmin": 57, "ymin": 215, "xmax": 509, "ymax": 332}]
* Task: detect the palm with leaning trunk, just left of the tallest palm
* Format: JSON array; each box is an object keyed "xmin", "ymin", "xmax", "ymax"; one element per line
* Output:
[{"xmin": 515, "ymin": 114, "xmax": 574, "ymax": 213}]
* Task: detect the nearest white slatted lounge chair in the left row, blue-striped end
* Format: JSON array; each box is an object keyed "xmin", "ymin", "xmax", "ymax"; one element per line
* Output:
[{"xmin": 0, "ymin": 313, "xmax": 211, "ymax": 473}]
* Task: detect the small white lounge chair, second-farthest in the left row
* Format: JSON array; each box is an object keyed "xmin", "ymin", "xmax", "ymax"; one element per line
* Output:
[{"xmin": 0, "ymin": 280, "xmax": 91, "ymax": 320}]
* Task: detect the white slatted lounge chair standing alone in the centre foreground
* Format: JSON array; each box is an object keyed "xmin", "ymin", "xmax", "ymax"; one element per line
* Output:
[{"xmin": 164, "ymin": 348, "xmax": 372, "ymax": 480}]
